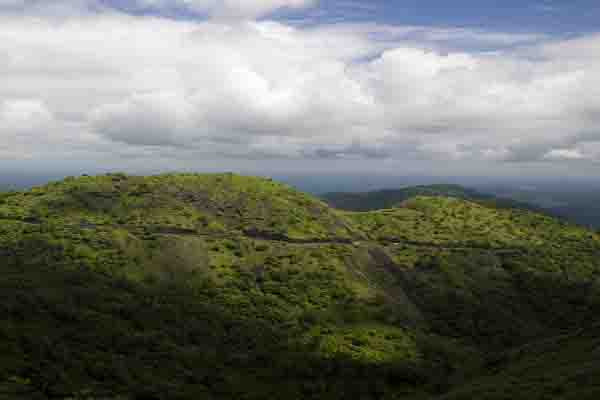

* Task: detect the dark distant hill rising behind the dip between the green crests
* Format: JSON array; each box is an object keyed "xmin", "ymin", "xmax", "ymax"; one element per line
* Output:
[{"xmin": 321, "ymin": 185, "xmax": 545, "ymax": 212}]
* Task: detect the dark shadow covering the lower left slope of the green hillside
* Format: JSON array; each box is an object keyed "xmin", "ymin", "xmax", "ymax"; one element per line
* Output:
[{"xmin": 0, "ymin": 260, "xmax": 443, "ymax": 399}]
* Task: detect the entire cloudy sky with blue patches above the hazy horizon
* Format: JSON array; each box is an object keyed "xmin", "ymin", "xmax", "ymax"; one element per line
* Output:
[{"xmin": 0, "ymin": 0, "xmax": 600, "ymax": 176}]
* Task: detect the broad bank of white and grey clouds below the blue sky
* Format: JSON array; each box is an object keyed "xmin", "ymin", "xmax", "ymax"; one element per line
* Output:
[{"xmin": 0, "ymin": 8, "xmax": 600, "ymax": 170}]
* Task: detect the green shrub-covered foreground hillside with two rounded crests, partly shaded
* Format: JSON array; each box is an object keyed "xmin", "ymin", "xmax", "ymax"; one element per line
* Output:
[{"xmin": 0, "ymin": 174, "xmax": 600, "ymax": 400}]
